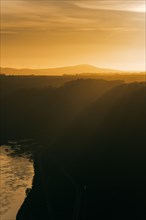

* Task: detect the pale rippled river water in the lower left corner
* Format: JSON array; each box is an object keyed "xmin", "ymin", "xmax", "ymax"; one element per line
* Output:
[{"xmin": 0, "ymin": 146, "xmax": 34, "ymax": 220}]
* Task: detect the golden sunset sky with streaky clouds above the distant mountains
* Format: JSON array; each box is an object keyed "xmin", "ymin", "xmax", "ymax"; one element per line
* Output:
[{"xmin": 0, "ymin": 0, "xmax": 146, "ymax": 71}]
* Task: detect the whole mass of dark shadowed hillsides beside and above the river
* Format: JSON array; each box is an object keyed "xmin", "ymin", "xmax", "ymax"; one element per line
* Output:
[{"xmin": 2, "ymin": 75, "xmax": 146, "ymax": 220}]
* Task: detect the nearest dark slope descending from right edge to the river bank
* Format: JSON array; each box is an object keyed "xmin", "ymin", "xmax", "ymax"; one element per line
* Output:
[{"xmin": 17, "ymin": 83, "xmax": 146, "ymax": 220}]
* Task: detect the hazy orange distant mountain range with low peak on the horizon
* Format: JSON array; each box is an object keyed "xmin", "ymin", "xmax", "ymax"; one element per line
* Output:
[{"xmin": 0, "ymin": 64, "xmax": 122, "ymax": 75}]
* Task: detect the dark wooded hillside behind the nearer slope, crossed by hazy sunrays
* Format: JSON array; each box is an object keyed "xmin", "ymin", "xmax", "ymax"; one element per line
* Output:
[{"xmin": 1, "ymin": 79, "xmax": 123, "ymax": 143}]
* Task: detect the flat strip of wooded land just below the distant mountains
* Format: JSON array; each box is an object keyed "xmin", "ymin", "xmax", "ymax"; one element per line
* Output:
[{"xmin": 0, "ymin": 73, "xmax": 146, "ymax": 96}]
